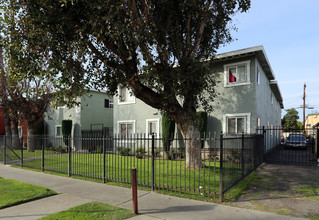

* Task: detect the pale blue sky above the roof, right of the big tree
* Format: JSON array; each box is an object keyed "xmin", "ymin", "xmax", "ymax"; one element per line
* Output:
[{"xmin": 217, "ymin": 0, "xmax": 319, "ymax": 121}]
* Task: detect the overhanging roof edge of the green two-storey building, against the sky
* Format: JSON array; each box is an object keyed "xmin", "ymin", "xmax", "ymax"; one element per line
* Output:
[{"xmin": 214, "ymin": 46, "xmax": 284, "ymax": 108}]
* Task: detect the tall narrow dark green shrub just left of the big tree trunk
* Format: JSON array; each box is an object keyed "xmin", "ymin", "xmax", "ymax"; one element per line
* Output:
[{"xmin": 162, "ymin": 113, "xmax": 175, "ymax": 152}]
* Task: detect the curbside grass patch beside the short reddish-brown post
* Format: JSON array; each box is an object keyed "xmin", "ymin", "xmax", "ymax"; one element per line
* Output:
[{"xmin": 41, "ymin": 202, "xmax": 135, "ymax": 220}]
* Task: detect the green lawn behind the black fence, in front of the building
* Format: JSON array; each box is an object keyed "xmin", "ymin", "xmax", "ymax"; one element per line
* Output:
[{"xmin": 24, "ymin": 153, "xmax": 219, "ymax": 194}]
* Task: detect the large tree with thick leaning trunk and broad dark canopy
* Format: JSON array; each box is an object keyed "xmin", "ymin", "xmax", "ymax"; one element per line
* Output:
[{"xmin": 16, "ymin": 0, "xmax": 250, "ymax": 167}]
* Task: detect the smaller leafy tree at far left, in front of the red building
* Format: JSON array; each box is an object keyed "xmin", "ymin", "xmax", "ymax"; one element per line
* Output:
[{"xmin": 0, "ymin": 0, "xmax": 52, "ymax": 151}]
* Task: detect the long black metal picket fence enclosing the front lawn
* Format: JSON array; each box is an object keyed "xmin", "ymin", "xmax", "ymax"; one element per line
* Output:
[{"xmin": 0, "ymin": 134, "xmax": 264, "ymax": 199}]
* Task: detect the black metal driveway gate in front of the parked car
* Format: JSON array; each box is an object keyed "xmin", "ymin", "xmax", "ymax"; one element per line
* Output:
[{"xmin": 264, "ymin": 128, "xmax": 318, "ymax": 166}]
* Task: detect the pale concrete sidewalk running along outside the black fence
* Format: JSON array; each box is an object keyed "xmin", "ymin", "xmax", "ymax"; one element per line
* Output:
[{"xmin": 0, "ymin": 164, "xmax": 303, "ymax": 220}]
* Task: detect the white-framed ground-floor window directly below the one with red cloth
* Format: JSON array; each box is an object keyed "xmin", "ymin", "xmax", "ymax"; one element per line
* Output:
[{"xmin": 223, "ymin": 113, "xmax": 251, "ymax": 134}]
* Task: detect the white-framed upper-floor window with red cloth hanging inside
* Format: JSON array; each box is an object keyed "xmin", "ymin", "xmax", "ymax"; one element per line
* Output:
[{"xmin": 224, "ymin": 61, "xmax": 250, "ymax": 87}]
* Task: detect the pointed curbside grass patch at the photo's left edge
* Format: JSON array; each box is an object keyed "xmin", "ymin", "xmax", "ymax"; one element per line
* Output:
[{"xmin": 0, "ymin": 177, "xmax": 57, "ymax": 209}]
